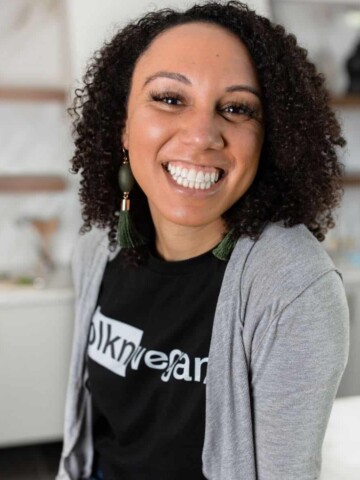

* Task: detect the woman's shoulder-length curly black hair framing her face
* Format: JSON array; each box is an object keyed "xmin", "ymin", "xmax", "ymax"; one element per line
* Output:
[{"xmin": 69, "ymin": 1, "xmax": 345, "ymax": 254}]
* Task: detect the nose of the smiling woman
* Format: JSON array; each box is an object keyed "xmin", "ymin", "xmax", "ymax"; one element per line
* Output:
[{"xmin": 181, "ymin": 111, "xmax": 225, "ymax": 150}]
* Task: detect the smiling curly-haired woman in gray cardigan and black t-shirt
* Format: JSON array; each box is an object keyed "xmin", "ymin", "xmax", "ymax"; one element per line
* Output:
[{"xmin": 58, "ymin": 2, "xmax": 348, "ymax": 480}]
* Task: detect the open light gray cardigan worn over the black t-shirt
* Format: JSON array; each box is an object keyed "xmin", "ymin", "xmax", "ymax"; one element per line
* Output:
[{"xmin": 57, "ymin": 224, "xmax": 349, "ymax": 480}]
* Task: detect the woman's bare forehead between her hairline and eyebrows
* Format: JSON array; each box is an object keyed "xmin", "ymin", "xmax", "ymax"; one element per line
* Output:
[{"xmin": 134, "ymin": 22, "xmax": 258, "ymax": 84}]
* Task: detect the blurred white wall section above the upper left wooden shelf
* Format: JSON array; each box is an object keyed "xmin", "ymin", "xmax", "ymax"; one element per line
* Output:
[{"xmin": 0, "ymin": 0, "xmax": 66, "ymax": 88}]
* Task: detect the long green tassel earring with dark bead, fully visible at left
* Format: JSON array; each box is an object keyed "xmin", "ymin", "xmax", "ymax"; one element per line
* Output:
[{"xmin": 117, "ymin": 148, "xmax": 146, "ymax": 248}]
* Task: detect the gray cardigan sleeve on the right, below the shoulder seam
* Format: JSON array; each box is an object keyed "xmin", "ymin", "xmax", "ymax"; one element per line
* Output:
[{"xmin": 250, "ymin": 270, "xmax": 349, "ymax": 480}]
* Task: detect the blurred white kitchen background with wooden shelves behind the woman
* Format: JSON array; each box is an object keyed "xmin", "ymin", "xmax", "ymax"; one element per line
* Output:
[{"xmin": 0, "ymin": 0, "xmax": 360, "ymax": 480}]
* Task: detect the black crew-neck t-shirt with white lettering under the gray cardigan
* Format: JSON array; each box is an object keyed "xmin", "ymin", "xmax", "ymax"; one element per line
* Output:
[{"xmin": 88, "ymin": 251, "xmax": 226, "ymax": 480}]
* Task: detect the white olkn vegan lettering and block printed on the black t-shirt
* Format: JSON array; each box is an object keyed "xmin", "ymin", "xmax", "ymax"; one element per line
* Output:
[{"xmin": 88, "ymin": 307, "xmax": 208, "ymax": 383}]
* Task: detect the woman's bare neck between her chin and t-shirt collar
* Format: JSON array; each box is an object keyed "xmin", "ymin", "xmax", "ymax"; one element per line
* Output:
[{"xmin": 154, "ymin": 219, "xmax": 225, "ymax": 261}]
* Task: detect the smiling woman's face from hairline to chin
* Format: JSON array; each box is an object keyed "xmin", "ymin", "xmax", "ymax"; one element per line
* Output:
[{"xmin": 122, "ymin": 23, "xmax": 264, "ymax": 232}]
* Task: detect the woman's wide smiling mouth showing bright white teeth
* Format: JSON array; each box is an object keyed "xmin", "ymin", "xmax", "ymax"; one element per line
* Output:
[{"xmin": 162, "ymin": 162, "xmax": 225, "ymax": 190}]
